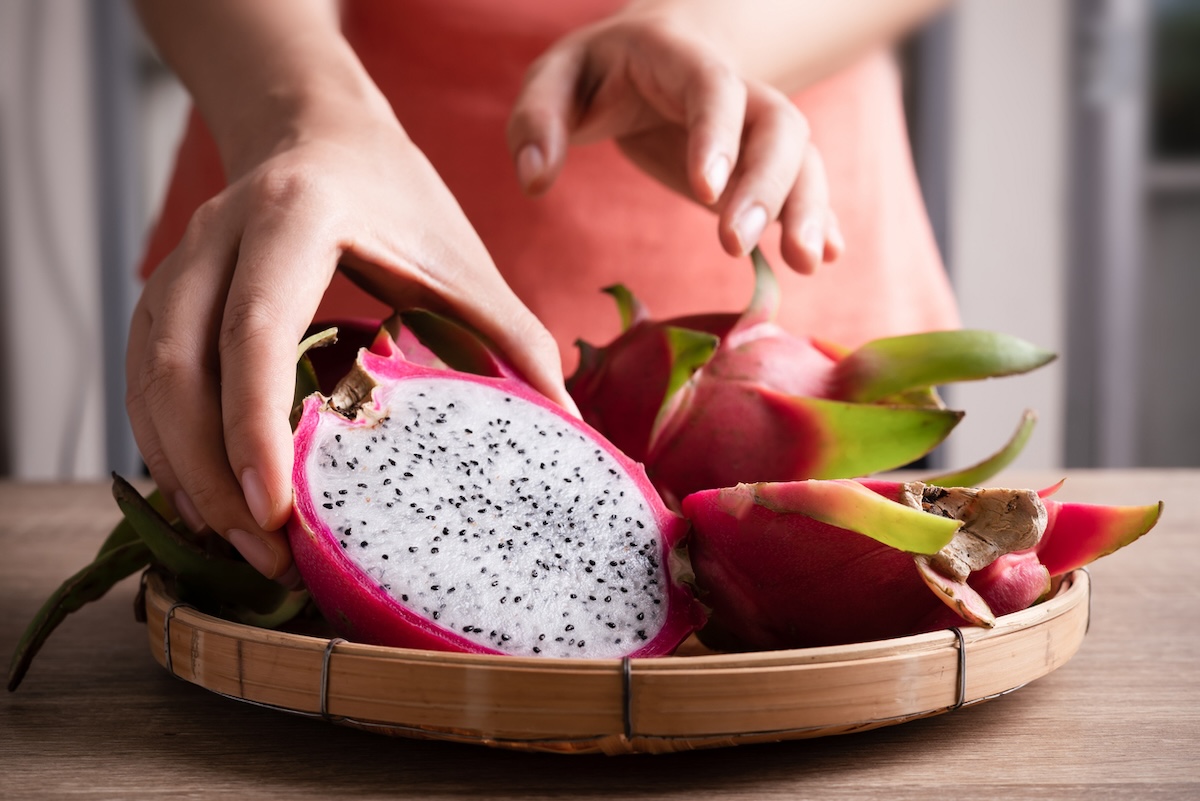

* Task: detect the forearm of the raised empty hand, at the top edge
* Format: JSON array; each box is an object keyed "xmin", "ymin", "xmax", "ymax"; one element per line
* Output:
[{"xmin": 625, "ymin": 0, "xmax": 948, "ymax": 92}]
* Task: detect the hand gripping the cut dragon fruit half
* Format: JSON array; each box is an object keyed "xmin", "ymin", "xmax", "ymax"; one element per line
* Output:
[{"xmin": 126, "ymin": 107, "xmax": 574, "ymax": 577}]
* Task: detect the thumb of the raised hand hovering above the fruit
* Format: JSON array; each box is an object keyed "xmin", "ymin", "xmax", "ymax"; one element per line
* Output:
[{"xmin": 506, "ymin": 44, "xmax": 583, "ymax": 195}]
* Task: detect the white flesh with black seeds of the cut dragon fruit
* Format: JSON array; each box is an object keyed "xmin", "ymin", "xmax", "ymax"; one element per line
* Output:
[{"xmin": 306, "ymin": 378, "xmax": 668, "ymax": 657}]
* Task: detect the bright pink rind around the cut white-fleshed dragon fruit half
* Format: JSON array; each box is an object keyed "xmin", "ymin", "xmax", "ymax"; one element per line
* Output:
[{"xmin": 288, "ymin": 338, "xmax": 704, "ymax": 657}]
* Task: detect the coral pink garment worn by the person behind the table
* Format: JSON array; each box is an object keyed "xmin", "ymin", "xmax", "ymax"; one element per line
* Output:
[{"xmin": 143, "ymin": 0, "xmax": 958, "ymax": 365}]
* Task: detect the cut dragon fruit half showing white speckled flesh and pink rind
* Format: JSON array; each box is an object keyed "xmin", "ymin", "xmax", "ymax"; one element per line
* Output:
[{"xmin": 288, "ymin": 315, "xmax": 703, "ymax": 657}]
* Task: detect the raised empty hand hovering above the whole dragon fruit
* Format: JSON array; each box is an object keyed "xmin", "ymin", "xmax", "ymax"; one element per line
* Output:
[{"xmin": 508, "ymin": 10, "xmax": 845, "ymax": 273}]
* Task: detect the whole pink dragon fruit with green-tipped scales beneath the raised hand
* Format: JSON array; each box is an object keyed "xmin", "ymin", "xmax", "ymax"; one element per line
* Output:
[{"xmin": 568, "ymin": 251, "xmax": 1054, "ymax": 506}]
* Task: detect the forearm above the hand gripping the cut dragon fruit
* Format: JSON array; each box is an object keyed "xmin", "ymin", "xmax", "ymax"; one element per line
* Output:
[{"xmin": 136, "ymin": 0, "xmax": 391, "ymax": 179}]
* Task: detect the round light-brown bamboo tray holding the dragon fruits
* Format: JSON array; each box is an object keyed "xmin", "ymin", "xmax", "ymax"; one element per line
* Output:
[{"xmin": 145, "ymin": 571, "xmax": 1091, "ymax": 754}]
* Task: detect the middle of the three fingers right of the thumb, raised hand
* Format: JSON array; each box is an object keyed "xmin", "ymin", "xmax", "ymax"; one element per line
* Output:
[{"xmin": 718, "ymin": 86, "xmax": 809, "ymax": 255}]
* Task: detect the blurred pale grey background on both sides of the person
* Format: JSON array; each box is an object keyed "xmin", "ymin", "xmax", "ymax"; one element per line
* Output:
[{"xmin": 0, "ymin": 0, "xmax": 1200, "ymax": 480}]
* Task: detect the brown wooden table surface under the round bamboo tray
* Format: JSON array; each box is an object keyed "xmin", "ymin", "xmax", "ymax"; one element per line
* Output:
[{"xmin": 0, "ymin": 470, "xmax": 1200, "ymax": 801}]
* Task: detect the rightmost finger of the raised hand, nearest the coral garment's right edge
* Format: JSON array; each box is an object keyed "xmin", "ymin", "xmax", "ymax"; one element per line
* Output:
[{"xmin": 779, "ymin": 145, "xmax": 845, "ymax": 275}]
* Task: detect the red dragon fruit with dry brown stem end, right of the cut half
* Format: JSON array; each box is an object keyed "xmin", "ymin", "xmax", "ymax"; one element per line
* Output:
[{"xmin": 683, "ymin": 480, "xmax": 1162, "ymax": 650}]
